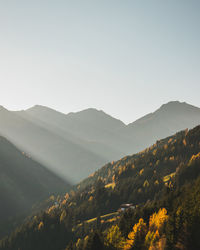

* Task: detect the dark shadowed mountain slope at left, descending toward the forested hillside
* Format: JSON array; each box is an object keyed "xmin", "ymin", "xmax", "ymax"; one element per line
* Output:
[{"xmin": 0, "ymin": 137, "xmax": 70, "ymax": 237}]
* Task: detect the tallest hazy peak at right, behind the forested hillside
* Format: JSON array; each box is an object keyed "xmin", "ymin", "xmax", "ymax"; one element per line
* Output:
[{"xmin": 119, "ymin": 101, "xmax": 200, "ymax": 153}]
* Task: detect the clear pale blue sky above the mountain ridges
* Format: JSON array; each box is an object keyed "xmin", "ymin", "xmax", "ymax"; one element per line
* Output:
[{"xmin": 0, "ymin": 0, "xmax": 200, "ymax": 123}]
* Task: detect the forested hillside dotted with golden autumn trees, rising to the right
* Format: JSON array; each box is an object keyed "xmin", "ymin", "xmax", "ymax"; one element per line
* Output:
[{"xmin": 0, "ymin": 126, "xmax": 200, "ymax": 250}]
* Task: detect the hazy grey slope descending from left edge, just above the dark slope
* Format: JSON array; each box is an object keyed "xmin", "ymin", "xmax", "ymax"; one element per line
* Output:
[{"xmin": 0, "ymin": 108, "xmax": 107, "ymax": 182}]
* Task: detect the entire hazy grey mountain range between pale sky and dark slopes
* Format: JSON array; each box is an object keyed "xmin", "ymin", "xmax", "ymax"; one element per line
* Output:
[{"xmin": 0, "ymin": 101, "xmax": 200, "ymax": 183}]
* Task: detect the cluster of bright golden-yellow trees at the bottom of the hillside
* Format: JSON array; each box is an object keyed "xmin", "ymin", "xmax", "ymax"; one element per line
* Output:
[{"xmin": 105, "ymin": 208, "xmax": 168, "ymax": 250}]
